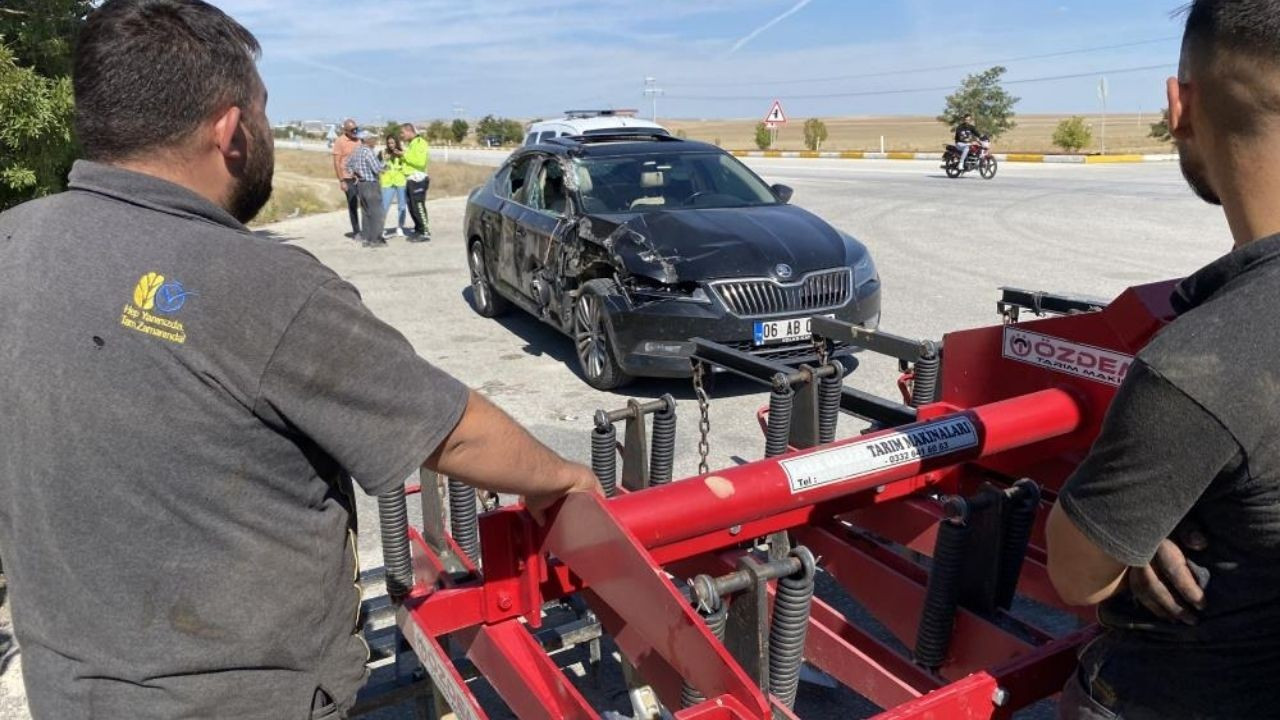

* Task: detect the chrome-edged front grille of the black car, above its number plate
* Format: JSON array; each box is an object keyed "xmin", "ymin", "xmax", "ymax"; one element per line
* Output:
[{"xmin": 710, "ymin": 268, "xmax": 852, "ymax": 318}]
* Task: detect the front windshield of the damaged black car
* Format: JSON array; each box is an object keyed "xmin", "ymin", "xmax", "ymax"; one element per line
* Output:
[{"xmin": 575, "ymin": 152, "xmax": 778, "ymax": 214}]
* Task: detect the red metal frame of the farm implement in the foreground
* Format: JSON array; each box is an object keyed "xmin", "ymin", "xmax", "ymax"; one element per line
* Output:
[{"xmin": 399, "ymin": 283, "xmax": 1172, "ymax": 720}]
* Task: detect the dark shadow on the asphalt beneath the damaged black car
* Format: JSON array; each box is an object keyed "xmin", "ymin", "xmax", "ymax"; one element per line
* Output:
[{"xmin": 462, "ymin": 286, "xmax": 768, "ymax": 400}]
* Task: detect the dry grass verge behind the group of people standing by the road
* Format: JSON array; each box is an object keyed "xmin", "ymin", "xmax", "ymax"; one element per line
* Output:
[{"xmin": 250, "ymin": 149, "xmax": 493, "ymax": 225}]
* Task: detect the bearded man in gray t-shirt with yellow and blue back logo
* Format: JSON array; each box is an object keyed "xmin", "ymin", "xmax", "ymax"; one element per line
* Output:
[{"xmin": 0, "ymin": 0, "xmax": 595, "ymax": 720}]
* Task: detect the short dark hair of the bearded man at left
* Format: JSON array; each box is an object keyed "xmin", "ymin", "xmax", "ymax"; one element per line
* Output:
[{"xmin": 73, "ymin": 0, "xmax": 261, "ymax": 161}]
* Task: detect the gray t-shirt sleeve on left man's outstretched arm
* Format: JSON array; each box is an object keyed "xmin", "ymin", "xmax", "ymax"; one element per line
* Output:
[{"xmin": 255, "ymin": 279, "xmax": 468, "ymax": 495}]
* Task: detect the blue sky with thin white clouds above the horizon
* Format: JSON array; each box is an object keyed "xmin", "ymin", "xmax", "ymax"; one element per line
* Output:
[{"xmin": 215, "ymin": 0, "xmax": 1183, "ymax": 122}]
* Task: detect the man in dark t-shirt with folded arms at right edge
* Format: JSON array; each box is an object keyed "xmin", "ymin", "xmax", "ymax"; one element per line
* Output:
[{"xmin": 1047, "ymin": 0, "xmax": 1280, "ymax": 720}]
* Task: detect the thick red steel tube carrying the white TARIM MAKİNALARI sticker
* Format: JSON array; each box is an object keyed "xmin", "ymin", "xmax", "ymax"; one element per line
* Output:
[{"xmin": 608, "ymin": 388, "xmax": 1083, "ymax": 548}]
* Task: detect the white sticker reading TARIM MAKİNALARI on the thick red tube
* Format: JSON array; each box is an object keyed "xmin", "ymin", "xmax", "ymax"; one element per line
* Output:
[{"xmin": 778, "ymin": 418, "xmax": 978, "ymax": 495}]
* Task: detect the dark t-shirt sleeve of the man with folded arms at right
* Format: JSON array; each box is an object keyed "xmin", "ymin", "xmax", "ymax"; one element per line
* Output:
[{"xmin": 1059, "ymin": 360, "xmax": 1240, "ymax": 566}]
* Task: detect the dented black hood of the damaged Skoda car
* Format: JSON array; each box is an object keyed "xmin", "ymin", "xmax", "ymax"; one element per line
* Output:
[{"xmin": 588, "ymin": 205, "xmax": 867, "ymax": 283}]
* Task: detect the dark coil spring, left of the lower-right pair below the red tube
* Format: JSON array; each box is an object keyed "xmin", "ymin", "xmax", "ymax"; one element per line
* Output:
[{"xmin": 915, "ymin": 509, "xmax": 970, "ymax": 670}]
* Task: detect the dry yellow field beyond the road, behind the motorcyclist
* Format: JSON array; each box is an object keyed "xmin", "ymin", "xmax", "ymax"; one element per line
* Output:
[{"xmin": 659, "ymin": 113, "xmax": 1170, "ymax": 154}]
